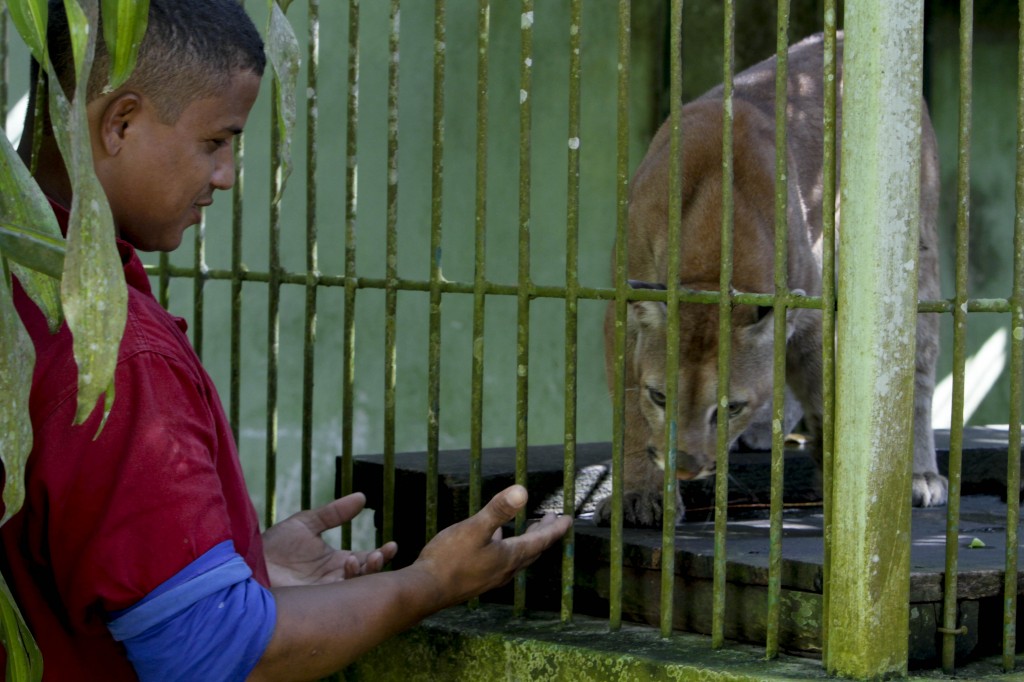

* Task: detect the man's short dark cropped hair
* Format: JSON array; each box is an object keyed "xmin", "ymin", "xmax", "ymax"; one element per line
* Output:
[{"xmin": 46, "ymin": 0, "xmax": 266, "ymax": 123}]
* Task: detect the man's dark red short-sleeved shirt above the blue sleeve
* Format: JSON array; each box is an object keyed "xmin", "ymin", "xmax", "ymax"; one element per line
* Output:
[{"xmin": 0, "ymin": 204, "xmax": 269, "ymax": 681}]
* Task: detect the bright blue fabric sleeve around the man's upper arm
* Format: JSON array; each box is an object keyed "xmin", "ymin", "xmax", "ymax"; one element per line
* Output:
[{"xmin": 108, "ymin": 541, "xmax": 276, "ymax": 682}]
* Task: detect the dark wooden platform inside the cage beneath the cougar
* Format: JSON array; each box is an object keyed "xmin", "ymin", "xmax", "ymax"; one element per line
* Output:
[{"xmin": 338, "ymin": 427, "xmax": 1024, "ymax": 666}]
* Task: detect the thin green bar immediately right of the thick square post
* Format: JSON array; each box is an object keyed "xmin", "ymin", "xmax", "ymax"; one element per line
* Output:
[{"xmin": 940, "ymin": 0, "xmax": 974, "ymax": 675}]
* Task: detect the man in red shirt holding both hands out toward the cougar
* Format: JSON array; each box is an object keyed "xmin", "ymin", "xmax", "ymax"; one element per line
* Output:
[{"xmin": 0, "ymin": 0, "xmax": 571, "ymax": 680}]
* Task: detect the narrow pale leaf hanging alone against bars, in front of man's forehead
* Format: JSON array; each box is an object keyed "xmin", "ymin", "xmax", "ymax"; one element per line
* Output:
[{"xmin": 266, "ymin": 0, "xmax": 299, "ymax": 202}]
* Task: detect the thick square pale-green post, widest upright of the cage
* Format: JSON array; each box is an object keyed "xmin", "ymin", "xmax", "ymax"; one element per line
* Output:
[{"xmin": 826, "ymin": 0, "xmax": 924, "ymax": 678}]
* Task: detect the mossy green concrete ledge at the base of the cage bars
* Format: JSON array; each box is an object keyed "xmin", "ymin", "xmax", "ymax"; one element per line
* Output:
[{"xmin": 342, "ymin": 605, "xmax": 1024, "ymax": 682}]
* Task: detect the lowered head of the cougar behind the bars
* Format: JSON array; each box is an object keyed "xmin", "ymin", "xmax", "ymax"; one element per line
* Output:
[{"xmin": 627, "ymin": 284, "xmax": 792, "ymax": 480}]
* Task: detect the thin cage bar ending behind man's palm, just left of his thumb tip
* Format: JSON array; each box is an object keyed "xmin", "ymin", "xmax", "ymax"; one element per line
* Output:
[{"xmin": 469, "ymin": 0, "xmax": 490, "ymax": 514}]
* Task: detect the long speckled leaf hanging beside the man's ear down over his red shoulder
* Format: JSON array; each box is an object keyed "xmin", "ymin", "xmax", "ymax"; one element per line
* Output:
[{"xmin": 50, "ymin": 0, "xmax": 128, "ymax": 424}]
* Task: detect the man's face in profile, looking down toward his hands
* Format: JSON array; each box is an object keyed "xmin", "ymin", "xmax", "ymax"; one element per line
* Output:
[{"xmin": 96, "ymin": 72, "xmax": 260, "ymax": 251}]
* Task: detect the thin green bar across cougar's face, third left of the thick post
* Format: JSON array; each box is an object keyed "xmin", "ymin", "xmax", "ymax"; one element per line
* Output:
[{"xmin": 711, "ymin": 0, "xmax": 736, "ymax": 648}]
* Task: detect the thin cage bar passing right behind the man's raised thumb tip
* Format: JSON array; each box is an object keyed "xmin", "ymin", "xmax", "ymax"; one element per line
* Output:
[{"xmin": 513, "ymin": 0, "xmax": 534, "ymax": 615}]
